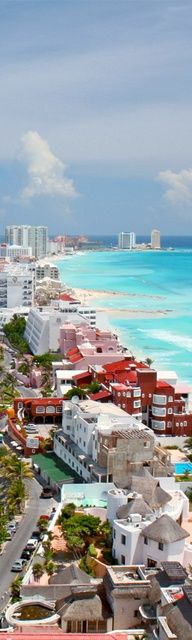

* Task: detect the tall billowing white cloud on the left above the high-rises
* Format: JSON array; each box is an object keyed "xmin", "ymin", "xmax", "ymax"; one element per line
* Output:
[{"xmin": 19, "ymin": 131, "xmax": 77, "ymax": 199}]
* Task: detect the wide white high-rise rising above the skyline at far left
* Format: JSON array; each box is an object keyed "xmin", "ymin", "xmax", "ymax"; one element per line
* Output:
[{"xmin": 5, "ymin": 224, "xmax": 48, "ymax": 258}]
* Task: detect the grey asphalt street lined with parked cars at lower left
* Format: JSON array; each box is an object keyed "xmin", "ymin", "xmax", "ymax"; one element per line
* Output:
[{"xmin": 0, "ymin": 479, "xmax": 56, "ymax": 613}]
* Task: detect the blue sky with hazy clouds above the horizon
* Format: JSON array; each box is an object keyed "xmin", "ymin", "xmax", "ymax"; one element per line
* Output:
[{"xmin": 0, "ymin": 0, "xmax": 192, "ymax": 235}]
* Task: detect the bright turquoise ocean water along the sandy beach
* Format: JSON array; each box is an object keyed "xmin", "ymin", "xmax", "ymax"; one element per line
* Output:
[{"xmin": 58, "ymin": 244, "xmax": 192, "ymax": 384}]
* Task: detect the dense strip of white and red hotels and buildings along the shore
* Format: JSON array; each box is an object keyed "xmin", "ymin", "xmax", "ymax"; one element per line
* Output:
[{"xmin": 0, "ymin": 227, "xmax": 192, "ymax": 640}]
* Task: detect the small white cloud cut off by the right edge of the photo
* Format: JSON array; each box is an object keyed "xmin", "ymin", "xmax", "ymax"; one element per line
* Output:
[{"xmin": 158, "ymin": 169, "xmax": 192, "ymax": 204}]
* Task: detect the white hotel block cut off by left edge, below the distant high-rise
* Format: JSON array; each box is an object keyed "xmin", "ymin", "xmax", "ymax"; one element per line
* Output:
[{"xmin": 0, "ymin": 264, "xmax": 34, "ymax": 308}]
